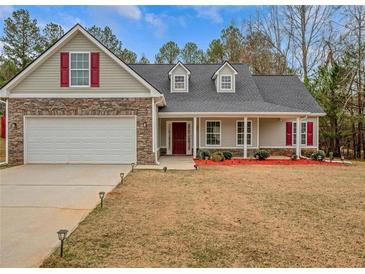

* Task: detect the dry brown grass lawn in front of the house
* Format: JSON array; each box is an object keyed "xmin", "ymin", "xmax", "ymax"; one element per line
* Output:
[{"xmin": 43, "ymin": 163, "xmax": 365, "ymax": 267}]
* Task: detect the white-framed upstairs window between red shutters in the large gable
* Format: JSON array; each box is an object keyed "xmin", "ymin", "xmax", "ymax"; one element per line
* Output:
[{"xmin": 70, "ymin": 52, "xmax": 90, "ymax": 87}]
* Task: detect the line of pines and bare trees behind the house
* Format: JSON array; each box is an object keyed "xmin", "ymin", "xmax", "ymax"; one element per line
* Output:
[{"xmin": 0, "ymin": 6, "xmax": 365, "ymax": 159}]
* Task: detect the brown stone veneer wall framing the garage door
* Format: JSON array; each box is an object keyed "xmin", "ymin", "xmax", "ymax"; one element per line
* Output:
[{"xmin": 8, "ymin": 98, "xmax": 155, "ymax": 165}]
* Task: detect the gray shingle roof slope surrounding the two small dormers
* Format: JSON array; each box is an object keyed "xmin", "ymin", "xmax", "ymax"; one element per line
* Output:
[{"xmin": 130, "ymin": 64, "xmax": 323, "ymax": 113}]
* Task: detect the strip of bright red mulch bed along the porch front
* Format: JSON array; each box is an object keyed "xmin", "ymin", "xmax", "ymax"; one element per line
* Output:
[{"xmin": 194, "ymin": 158, "xmax": 343, "ymax": 166}]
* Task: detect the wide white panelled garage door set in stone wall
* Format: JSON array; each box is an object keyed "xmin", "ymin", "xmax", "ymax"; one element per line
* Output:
[{"xmin": 24, "ymin": 117, "xmax": 136, "ymax": 164}]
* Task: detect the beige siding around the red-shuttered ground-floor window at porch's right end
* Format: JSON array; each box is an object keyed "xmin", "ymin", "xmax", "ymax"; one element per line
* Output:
[{"xmin": 260, "ymin": 118, "xmax": 318, "ymax": 147}]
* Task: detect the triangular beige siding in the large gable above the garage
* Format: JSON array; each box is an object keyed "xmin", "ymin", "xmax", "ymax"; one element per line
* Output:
[{"xmin": 12, "ymin": 32, "xmax": 149, "ymax": 95}]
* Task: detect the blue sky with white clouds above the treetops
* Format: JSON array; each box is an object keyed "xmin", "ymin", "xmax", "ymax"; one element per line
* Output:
[{"xmin": 0, "ymin": 6, "xmax": 265, "ymax": 61}]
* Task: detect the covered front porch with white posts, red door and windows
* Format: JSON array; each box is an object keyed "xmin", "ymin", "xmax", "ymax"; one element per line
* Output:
[{"xmin": 157, "ymin": 113, "xmax": 318, "ymax": 158}]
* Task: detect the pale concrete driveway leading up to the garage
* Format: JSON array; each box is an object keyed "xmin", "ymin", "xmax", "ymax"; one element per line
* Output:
[{"xmin": 0, "ymin": 165, "xmax": 130, "ymax": 267}]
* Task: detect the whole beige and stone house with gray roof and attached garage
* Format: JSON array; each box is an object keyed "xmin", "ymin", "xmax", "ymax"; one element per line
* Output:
[{"xmin": 0, "ymin": 24, "xmax": 325, "ymax": 164}]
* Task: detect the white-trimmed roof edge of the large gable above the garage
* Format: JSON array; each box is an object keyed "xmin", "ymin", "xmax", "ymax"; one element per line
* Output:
[{"xmin": 0, "ymin": 23, "xmax": 160, "ymax": 97}]
